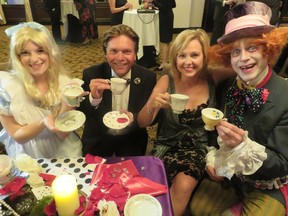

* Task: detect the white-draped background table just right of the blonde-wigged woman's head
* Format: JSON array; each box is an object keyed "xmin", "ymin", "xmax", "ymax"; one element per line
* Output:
[{"xmin": 60, "ymin": 0, "xmax": 79, "ymax": 38}]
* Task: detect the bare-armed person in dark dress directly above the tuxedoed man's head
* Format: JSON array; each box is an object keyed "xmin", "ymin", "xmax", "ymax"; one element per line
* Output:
[{"xmin": 108, "ymin": 0, "xmax": 133, "ymax": 26}]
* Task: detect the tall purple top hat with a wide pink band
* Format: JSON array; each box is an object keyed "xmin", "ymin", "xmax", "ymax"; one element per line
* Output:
[{"xmin": 217, "ymin": 1, "xmax": 275, "ymax": 44}]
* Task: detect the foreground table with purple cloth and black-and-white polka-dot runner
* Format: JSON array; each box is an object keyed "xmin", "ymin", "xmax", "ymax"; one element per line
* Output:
[{"xmin": 37, "ymin": 156, "xmax": 173, "ymax": 216}]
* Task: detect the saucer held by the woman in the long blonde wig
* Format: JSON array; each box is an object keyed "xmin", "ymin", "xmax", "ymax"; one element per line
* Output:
[{"xmin": 55, "ymin": 110, "xmax": 86, "ymax": 132}]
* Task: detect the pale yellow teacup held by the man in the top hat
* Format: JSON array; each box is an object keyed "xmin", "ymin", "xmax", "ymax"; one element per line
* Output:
[{"xmin": 201, "ymin": 108, "xmax": 224, "ymax": 131}]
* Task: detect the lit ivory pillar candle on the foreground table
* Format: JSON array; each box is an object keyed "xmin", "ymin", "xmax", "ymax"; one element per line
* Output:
[{"xmin": 52, "ymin": 174, "xmax": 80, "ymax": 216}]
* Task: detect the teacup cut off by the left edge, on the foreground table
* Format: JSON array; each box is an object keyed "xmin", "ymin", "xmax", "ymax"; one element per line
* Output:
[{"xmin": 0, "ymin": 155, "xmax": 15, "ymax": 184}]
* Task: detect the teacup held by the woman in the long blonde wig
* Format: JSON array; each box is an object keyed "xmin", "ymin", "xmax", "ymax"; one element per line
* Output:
[{"xmin": 62, "ymin": 84, "xmax": 84, "ymax": 107}]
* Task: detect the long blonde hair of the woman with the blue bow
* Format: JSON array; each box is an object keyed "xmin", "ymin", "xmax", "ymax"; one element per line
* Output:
[{"xmin": 10, "ymin": 26, "xmax": 66, "ymax": 109}]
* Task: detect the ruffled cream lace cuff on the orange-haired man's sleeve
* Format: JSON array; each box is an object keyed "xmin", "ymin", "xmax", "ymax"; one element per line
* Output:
[{"xmin": 214, "ymin": 131, "xmax": 267, "ymax": 179}]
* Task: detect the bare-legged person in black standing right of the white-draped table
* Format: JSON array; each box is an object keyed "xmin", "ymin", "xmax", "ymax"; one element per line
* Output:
[{"xmin": 152, "ymin": 0, "xmax": 176, "ymax": 71}]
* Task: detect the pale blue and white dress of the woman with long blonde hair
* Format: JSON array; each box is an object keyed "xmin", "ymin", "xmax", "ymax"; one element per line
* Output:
[{"xmin": 0, "ymin": 71, "xmax": 82, "ymax": 158}]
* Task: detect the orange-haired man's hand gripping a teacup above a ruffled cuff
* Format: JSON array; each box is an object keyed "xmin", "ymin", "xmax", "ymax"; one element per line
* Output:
[{"xmin": 216, "ymin": 120, "xmax": 245, "ymax": 148}]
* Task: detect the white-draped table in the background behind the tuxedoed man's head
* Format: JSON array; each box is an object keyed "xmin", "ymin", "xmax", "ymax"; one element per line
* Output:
[{"xmin": 122, "ymin": 9, "xmax": 160, "ymax": 59}]
